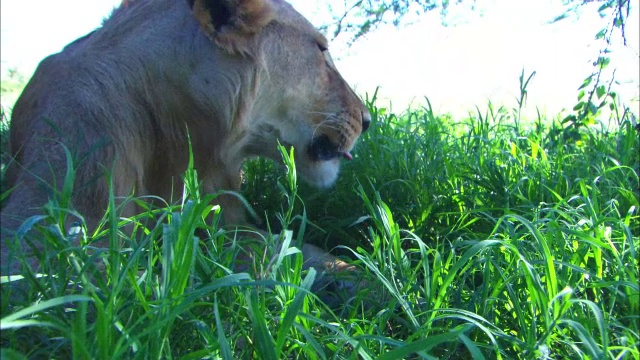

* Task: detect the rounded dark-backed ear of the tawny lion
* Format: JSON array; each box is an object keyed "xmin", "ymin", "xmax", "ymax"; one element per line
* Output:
[{"xmin": 187, "ymin": 0, "xmax": 273, "ymax": 53}]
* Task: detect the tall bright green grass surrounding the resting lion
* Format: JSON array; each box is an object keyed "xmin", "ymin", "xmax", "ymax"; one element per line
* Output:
[{"xmin": 0, "ymin": 88, "xmax": 640, "ymax": 359}]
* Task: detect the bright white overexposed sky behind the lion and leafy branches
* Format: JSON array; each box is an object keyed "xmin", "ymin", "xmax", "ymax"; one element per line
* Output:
[{"xmin": 0, "ymin": 0, "xmax": 640, "ymax": 116}]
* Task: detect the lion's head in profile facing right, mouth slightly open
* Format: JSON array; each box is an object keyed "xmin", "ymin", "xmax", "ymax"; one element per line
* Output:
[{"xmin": 186, "ymin": 0, "xmax": 370, "ymax": 187}]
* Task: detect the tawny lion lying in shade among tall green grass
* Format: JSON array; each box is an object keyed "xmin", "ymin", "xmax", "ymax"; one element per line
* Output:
[{"xmin": 1, "ymin": 0, "xmax": 371, "ymax": 278}]
